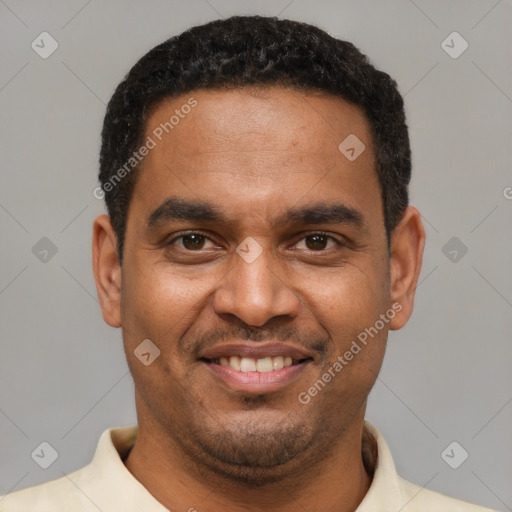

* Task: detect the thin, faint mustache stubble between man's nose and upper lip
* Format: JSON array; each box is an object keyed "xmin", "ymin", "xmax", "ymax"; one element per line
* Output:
[{"xmin": 181, "ymin": 326, "xmax": 330, "ymax": 360}]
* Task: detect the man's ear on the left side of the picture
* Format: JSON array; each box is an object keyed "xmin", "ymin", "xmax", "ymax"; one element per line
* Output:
[{"xmin": 92, "ymin": 214, "xmax": 121, "ymax": 327}]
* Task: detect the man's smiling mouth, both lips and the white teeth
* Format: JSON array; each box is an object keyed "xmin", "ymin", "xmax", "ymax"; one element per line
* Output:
[{"xmin": 199, "ymin": 344, "xmax": 313, "ymax": 395}]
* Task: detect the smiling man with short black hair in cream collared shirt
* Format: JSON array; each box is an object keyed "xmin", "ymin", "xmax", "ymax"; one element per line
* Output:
[{"xmin": 0, "ymin": 17, "xmax": 496, "ymax": 512}]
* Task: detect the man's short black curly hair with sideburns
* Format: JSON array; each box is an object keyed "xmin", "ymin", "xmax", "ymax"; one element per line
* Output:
[{"xmin": 99, "ymin": 16, "xmax": 411, "ymax": 264}]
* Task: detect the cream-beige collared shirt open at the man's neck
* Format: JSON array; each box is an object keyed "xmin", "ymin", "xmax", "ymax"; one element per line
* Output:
[{"xmin": 0, "ymin": 421, "xmax": 496, "ymax": 512}]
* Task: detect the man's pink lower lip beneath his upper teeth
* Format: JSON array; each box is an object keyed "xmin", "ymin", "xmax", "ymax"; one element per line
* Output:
[{"xmin": 203, "ymin": 361, "xmax": 310, "ymax": 395}]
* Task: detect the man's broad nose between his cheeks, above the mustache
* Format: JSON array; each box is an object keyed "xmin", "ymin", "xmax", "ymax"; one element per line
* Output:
[{"xmin": 213, "ymin": 243, "xmax": 300, "ymax": 327}]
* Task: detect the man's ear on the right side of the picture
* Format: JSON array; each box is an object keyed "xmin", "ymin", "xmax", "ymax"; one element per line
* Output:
[{"xmin": 389, "ymin": 206, "xmax": 425, "ymax": 330}]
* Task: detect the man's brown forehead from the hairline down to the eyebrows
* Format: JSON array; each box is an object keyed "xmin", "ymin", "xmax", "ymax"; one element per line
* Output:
[{"xmin": 130, "ymin": 87, "xmax": 380, "ymax": 234}]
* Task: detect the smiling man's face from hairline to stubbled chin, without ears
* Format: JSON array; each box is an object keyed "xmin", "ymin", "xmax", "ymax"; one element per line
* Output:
[{"xmin": 121, "ymin": 88, "xmax": 391, "ymax": 482}]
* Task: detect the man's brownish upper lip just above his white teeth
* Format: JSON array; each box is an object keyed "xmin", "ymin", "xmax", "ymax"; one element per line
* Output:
[{"xmin": 200, "ymin": 342, "xmax": 313, "ymax": 361}]
